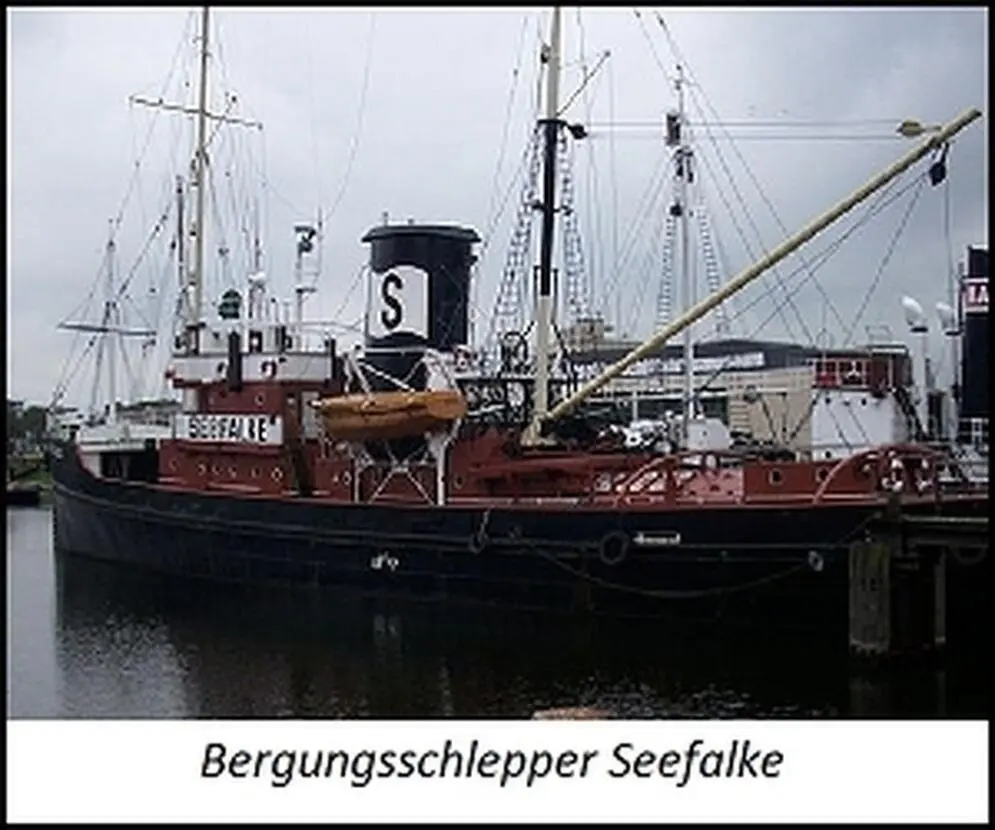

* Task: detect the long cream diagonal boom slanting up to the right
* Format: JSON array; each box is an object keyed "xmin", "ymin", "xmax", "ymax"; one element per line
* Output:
[{"xmin": 529, "ymin": 108, "xmax": 981, "ymax": 434}]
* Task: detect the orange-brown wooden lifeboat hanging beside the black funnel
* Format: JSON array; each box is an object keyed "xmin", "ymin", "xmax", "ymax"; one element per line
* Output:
[{"xmin": 313, "ymin": 389, "xmax": 467, "ymax": 441}]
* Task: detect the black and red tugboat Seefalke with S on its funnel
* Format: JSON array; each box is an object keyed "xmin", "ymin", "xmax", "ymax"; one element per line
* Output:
[{"xmin": 53, "ymin": 8, "xmax": 988, "ymax": 625}]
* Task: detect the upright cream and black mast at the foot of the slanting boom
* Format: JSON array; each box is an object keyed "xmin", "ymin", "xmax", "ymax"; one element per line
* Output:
[{"xmin": 533, "ymin": 6, "xmax": 561, "ymax": 446}]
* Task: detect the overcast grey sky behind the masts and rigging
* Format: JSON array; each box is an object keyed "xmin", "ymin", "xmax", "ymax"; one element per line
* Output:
[{"xmin": 7, "ymin": 6, "xmax": 988, "ymax": 404}]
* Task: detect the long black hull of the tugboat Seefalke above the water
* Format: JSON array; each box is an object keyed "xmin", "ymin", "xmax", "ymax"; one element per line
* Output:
[{"xmin": 46, "ymin": 450, "xmax": 980, "ymax": 630}]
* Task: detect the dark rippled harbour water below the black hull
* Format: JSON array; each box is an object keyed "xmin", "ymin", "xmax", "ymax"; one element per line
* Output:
[{"xmin": 7, "ymin": 508, "xmax": 989, "ymax": 718}]
